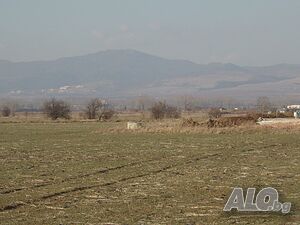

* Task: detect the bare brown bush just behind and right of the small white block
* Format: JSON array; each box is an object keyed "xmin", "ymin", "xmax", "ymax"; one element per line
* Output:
[{"xmin": 151, "ymin": 102, "xmax": 180, "ymax": 120}]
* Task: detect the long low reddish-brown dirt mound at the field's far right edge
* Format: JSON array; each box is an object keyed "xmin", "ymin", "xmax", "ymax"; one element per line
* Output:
[{"xmin": 207, "ymin": 116, "xmax": 257, "ymax": 127}]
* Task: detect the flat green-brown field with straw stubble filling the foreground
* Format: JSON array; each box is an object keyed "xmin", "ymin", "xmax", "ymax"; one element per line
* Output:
[{"xmin": 0, "ymin": 121, "xmax": 300, "ymax": 225}]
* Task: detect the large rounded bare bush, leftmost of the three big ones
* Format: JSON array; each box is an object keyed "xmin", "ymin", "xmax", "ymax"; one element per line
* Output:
[{"xmin": 43, "ymin": 98, "xmax": 71, "ymax": 120}]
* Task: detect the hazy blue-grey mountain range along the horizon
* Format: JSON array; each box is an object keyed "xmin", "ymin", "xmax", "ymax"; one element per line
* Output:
[{"xmin": 0, "ymin": 50, "xmax": 300, "ymax": 98}]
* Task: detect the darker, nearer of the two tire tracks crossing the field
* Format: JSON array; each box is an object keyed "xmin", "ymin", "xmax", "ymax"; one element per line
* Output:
[{"xmin": 0, "ymin": 153, "xmax": 221, "ymax": 212}]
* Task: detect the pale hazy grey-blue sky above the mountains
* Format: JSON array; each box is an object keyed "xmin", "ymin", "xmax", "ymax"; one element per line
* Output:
[{"xmin": 0, "ymin": 0, "xmax": 300, "ymax": 65}]
